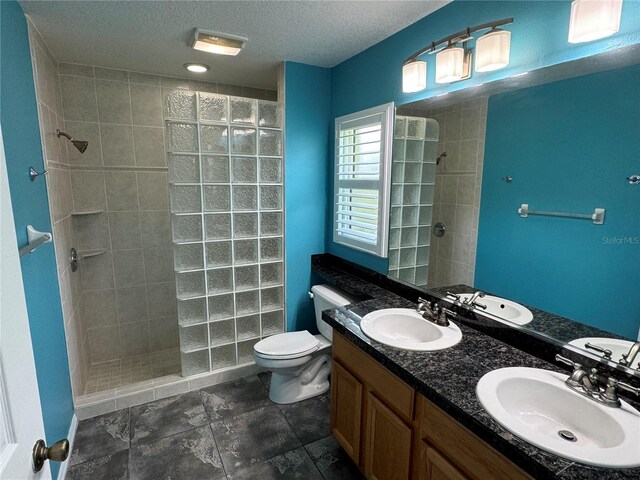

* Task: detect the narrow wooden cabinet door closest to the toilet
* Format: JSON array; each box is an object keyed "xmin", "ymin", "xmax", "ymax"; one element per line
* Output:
[{"xmin": 331, "ymin": 360, "xmax": 363, "ymax": 465}]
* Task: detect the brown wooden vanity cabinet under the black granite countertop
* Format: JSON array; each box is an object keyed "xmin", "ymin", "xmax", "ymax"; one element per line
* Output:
[{"xmin": 331, "ymin": 331, "xmax": 532, "ymax": 480}]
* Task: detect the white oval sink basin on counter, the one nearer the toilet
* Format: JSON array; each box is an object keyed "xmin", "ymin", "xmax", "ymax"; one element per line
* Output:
[{"xmin": 360, "ymin": 308, "xmax": 462, "ymax": 352}]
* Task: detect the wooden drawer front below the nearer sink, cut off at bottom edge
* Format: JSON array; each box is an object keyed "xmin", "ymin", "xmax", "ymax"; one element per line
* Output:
[{"xmin": 418, "ymin": 395, "xmax": 533, "ymax": 480}]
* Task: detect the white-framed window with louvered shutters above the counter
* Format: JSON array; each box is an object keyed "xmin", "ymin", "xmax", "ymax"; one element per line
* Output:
[{"xmin": 333, "ymin": 103, "xmax": 394, "ymax": 257}]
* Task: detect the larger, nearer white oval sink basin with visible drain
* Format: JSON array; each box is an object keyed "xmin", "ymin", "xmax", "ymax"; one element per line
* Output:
[{"xmin": 476, "ymin": 367, "xmax": 640, "ymax": 468}]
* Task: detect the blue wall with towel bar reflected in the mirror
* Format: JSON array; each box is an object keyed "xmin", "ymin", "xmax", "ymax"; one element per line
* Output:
[{"xmin": 475, "ymin": 65, "xmax": 640, "ymax": 338}]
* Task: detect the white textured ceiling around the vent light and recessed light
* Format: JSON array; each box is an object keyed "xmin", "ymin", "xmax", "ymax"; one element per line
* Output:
[{"xmin": 20, "ymin": 0, "xmax": 449, "ymax": 88}]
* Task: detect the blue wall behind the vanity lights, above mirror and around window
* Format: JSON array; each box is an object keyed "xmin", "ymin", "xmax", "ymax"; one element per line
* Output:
[{"xmin": 327, "ymin": 0, "xmax": 640, "ymax": 273}]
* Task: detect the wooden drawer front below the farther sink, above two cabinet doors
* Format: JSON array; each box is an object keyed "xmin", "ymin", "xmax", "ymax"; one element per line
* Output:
[{"xmin": 333, "ymin": 331, "xmax": 415, "ymax": 422}]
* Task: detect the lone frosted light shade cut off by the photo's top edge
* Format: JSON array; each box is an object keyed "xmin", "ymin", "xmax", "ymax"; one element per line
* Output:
[{"xmin": 569, "ymin": 0, "xmax": 622, "ymax": 43}]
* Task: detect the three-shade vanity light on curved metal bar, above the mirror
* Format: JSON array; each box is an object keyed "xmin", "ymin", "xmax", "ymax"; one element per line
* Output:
[{"xmin": 402, "ymin": 18, "xmax": 513, "ymax": 92}]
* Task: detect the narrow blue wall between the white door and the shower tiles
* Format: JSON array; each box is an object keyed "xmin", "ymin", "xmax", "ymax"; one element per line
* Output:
[{"xmin": 0, "ymin": 1, "xmax": 73, "ymax": 478}]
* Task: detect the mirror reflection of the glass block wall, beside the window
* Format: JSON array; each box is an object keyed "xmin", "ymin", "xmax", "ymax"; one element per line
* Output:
[{"xmin": 389, "ymin": 115, "xmax": 439, "ymax": 287}]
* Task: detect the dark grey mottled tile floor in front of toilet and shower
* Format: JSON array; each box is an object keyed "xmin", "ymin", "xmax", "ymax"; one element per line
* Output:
[{"xmin": 67, "ymin": 373, "xmax": 364, "ymax": 480}]
